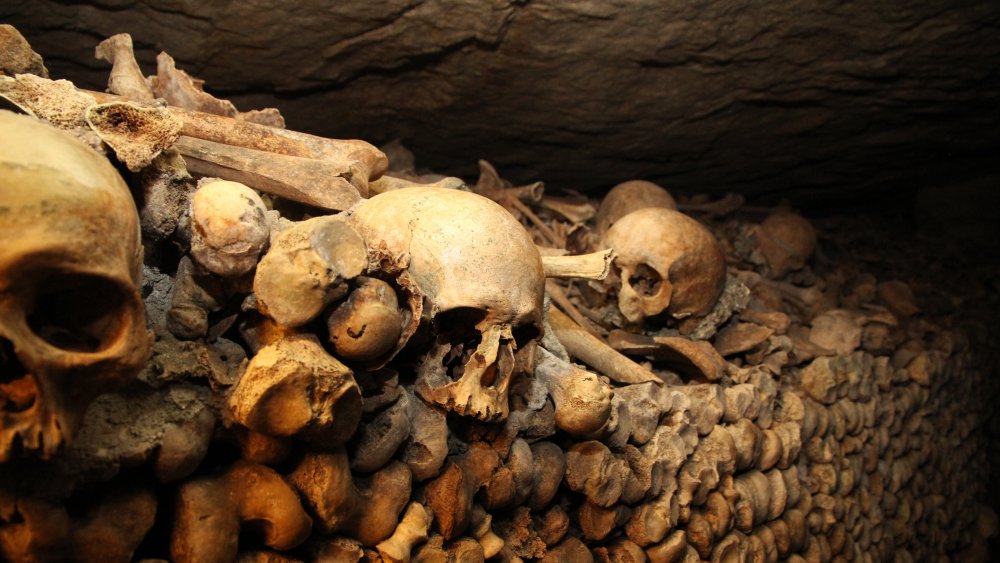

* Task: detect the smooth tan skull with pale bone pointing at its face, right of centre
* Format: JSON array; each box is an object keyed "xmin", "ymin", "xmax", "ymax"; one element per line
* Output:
[{"xmin": 603, "ymin": 207, "xmax": 726, "ymax": 323}]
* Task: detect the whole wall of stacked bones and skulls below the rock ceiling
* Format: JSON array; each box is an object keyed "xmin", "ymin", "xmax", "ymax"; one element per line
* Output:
[{"xmin": 0, "ymin": 26, "xmax": 998, "ymax": 563}]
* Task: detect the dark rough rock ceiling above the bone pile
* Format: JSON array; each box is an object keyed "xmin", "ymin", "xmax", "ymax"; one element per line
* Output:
[{"xmin": 0, "ymin": 0, "xmax": 1000, "ymax": 206}]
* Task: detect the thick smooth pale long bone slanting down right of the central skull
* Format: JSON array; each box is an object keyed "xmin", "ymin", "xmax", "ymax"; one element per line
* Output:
[{"xmin": 548, "ymin": 307, "xmax": 661, "ymax": 383}]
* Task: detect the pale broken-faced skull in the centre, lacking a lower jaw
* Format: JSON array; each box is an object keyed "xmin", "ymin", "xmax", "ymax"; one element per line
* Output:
[{"xmin": 352, "ymin": 188, "xmax": 545, "ymax": 421}]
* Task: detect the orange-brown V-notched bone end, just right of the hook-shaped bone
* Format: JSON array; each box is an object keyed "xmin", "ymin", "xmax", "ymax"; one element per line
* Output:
[{"xmin": 288, "ymin": 448, "xmax": 411, "ymax": 547}]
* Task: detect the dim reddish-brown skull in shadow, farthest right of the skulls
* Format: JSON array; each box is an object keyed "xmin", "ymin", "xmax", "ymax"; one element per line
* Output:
[{"xmin": 753, "ymin": 211, "xmax": 816, "ymax": 279}]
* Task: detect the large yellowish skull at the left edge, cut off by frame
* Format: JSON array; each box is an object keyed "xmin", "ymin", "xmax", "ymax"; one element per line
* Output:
[{"xmin": 0, "ymin": 111, "xmax": 150, "ymax": 462}]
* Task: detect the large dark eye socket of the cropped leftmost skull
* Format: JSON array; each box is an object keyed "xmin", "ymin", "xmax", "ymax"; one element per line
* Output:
[{"xmin": 25, "ymin": 272, "xmax": 131, "ymax": 353}]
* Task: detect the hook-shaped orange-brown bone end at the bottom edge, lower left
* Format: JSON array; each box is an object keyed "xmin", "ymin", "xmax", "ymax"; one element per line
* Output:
[{"xmin": 170, "ymin": 461, "xmax": 312, "ymax": 563}]
